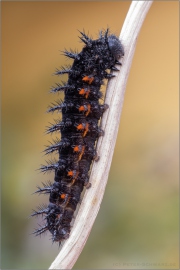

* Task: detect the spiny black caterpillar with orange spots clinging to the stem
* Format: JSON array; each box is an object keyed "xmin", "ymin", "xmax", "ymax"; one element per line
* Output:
[{"xmin": 32, "ymin": 29, "xmax": 124, "ymax": 244}]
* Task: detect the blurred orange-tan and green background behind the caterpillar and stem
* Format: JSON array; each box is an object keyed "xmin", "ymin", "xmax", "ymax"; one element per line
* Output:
[{"xmin": 1, "ymin": 1, "xmax": 179, "ymax": 269}]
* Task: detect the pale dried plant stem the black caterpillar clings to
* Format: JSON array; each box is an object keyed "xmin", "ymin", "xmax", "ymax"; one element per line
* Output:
[{"xmin": 49, "ymin": 1, "xmax": 153, "ymax": 269}]
